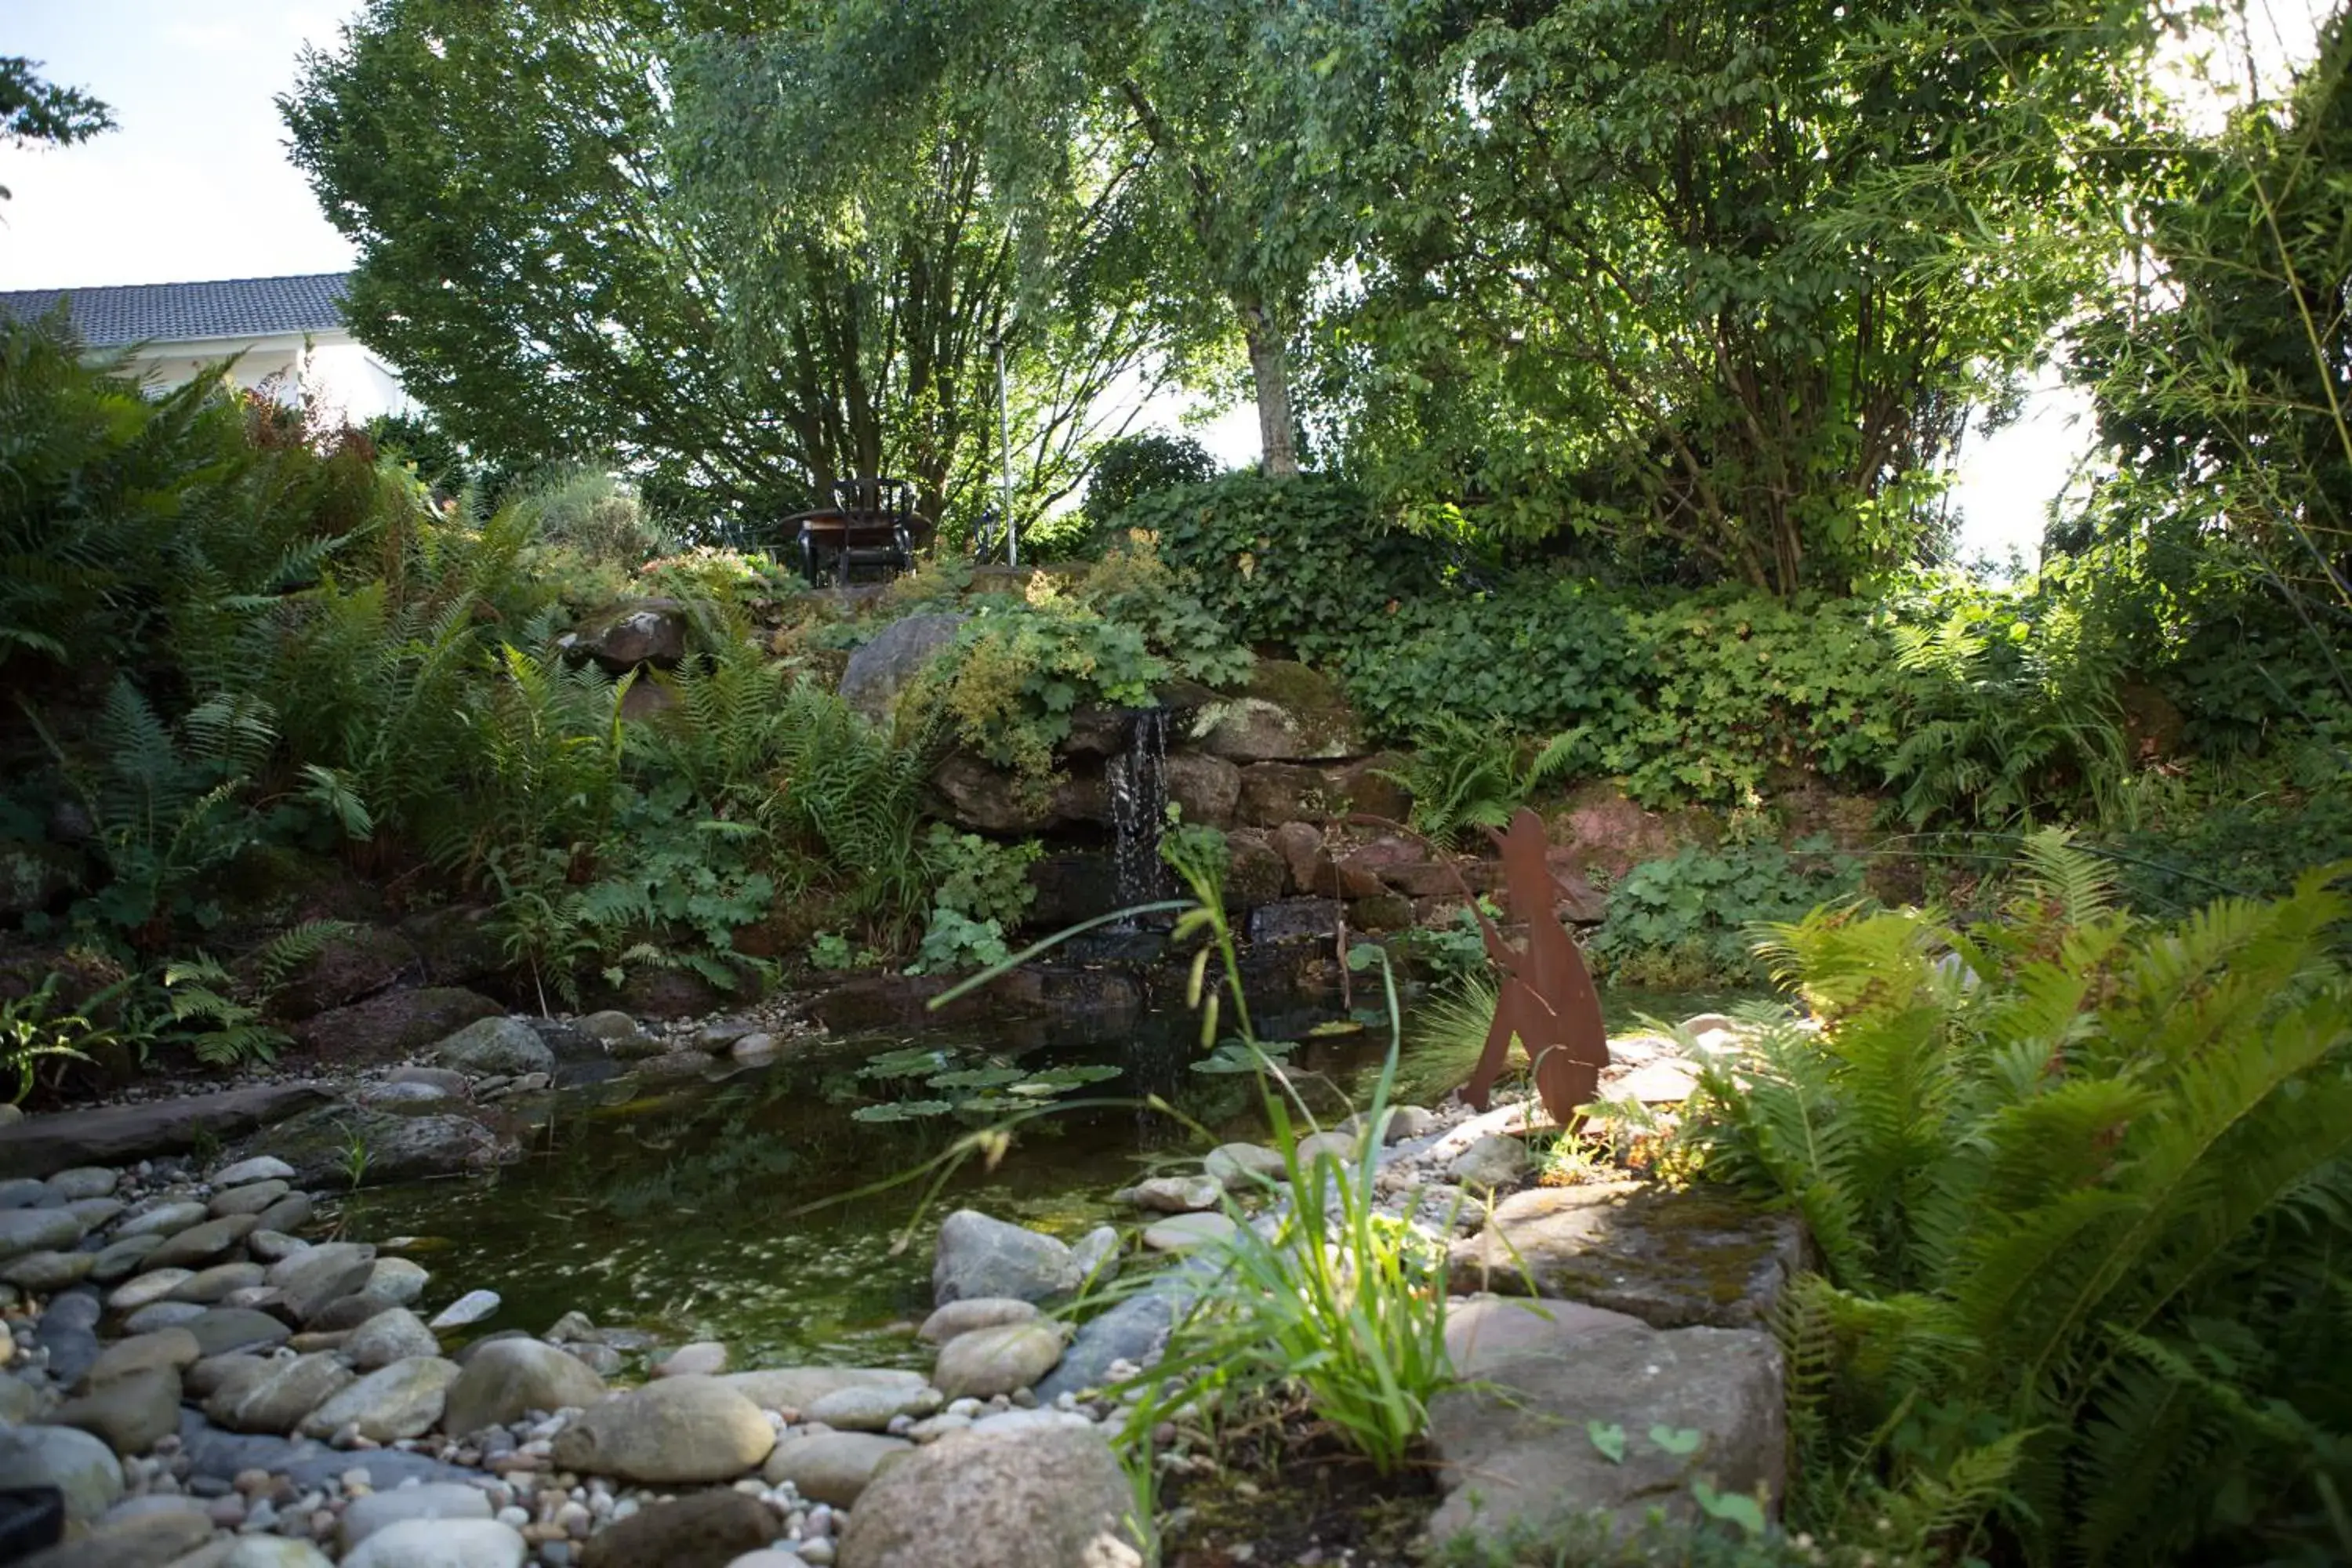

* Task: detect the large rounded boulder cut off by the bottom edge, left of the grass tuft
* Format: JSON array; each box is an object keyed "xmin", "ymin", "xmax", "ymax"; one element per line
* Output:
[{"xmin": 837, "ymin": 1427, "xmax": 1143, "ymax": 1568}]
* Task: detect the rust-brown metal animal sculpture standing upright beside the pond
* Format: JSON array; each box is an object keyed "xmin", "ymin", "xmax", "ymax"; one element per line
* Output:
[{"xmin": 1463, "ymin": 808, "xmax": 1609, "ymax": 1126}]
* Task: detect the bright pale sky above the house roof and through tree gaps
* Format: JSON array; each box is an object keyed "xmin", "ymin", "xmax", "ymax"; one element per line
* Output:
[{"xmin": 0, "ymin": 0, "xmax": 2331, "ymax": 562}]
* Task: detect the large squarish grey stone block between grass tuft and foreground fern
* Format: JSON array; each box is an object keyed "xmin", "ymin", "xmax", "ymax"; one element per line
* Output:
[{"xmin": 1430, "ymin": 1298, "xmax": 1788, "ymax": 1544}]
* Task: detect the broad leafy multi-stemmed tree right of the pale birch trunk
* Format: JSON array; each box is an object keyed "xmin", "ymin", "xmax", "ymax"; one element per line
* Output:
[{"xmin": 1324, "ymin": 0, "xmax": 2150, "ymax": 593}]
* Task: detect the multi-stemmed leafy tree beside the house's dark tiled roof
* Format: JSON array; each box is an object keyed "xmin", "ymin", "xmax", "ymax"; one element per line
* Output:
[{"xmin": 282, "ymin": 0, "xmax": 1185, "ymax": 526}]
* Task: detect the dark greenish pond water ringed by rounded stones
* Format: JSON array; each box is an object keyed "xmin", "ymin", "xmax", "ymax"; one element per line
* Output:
[{"xmin": 341, "ymin": 992, "xmax": 1724, "ymax": 1366}]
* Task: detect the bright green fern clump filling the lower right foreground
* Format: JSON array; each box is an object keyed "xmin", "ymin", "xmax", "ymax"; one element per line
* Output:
[{"xmin": 1686, "ymin": 832, "xmax": 2352, "ymax": 1563}]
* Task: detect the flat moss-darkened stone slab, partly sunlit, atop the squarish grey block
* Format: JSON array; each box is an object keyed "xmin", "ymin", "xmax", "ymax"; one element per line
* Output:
[{"xmin": 1451, "ymin": 1182, "xmax": 1804, "ymax": 1328}]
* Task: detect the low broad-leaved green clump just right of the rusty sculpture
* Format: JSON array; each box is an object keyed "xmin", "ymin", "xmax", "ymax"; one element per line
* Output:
[{"xmin": 1585, "ymin": 839, "xmax": 1863, "ymax": 987}]
